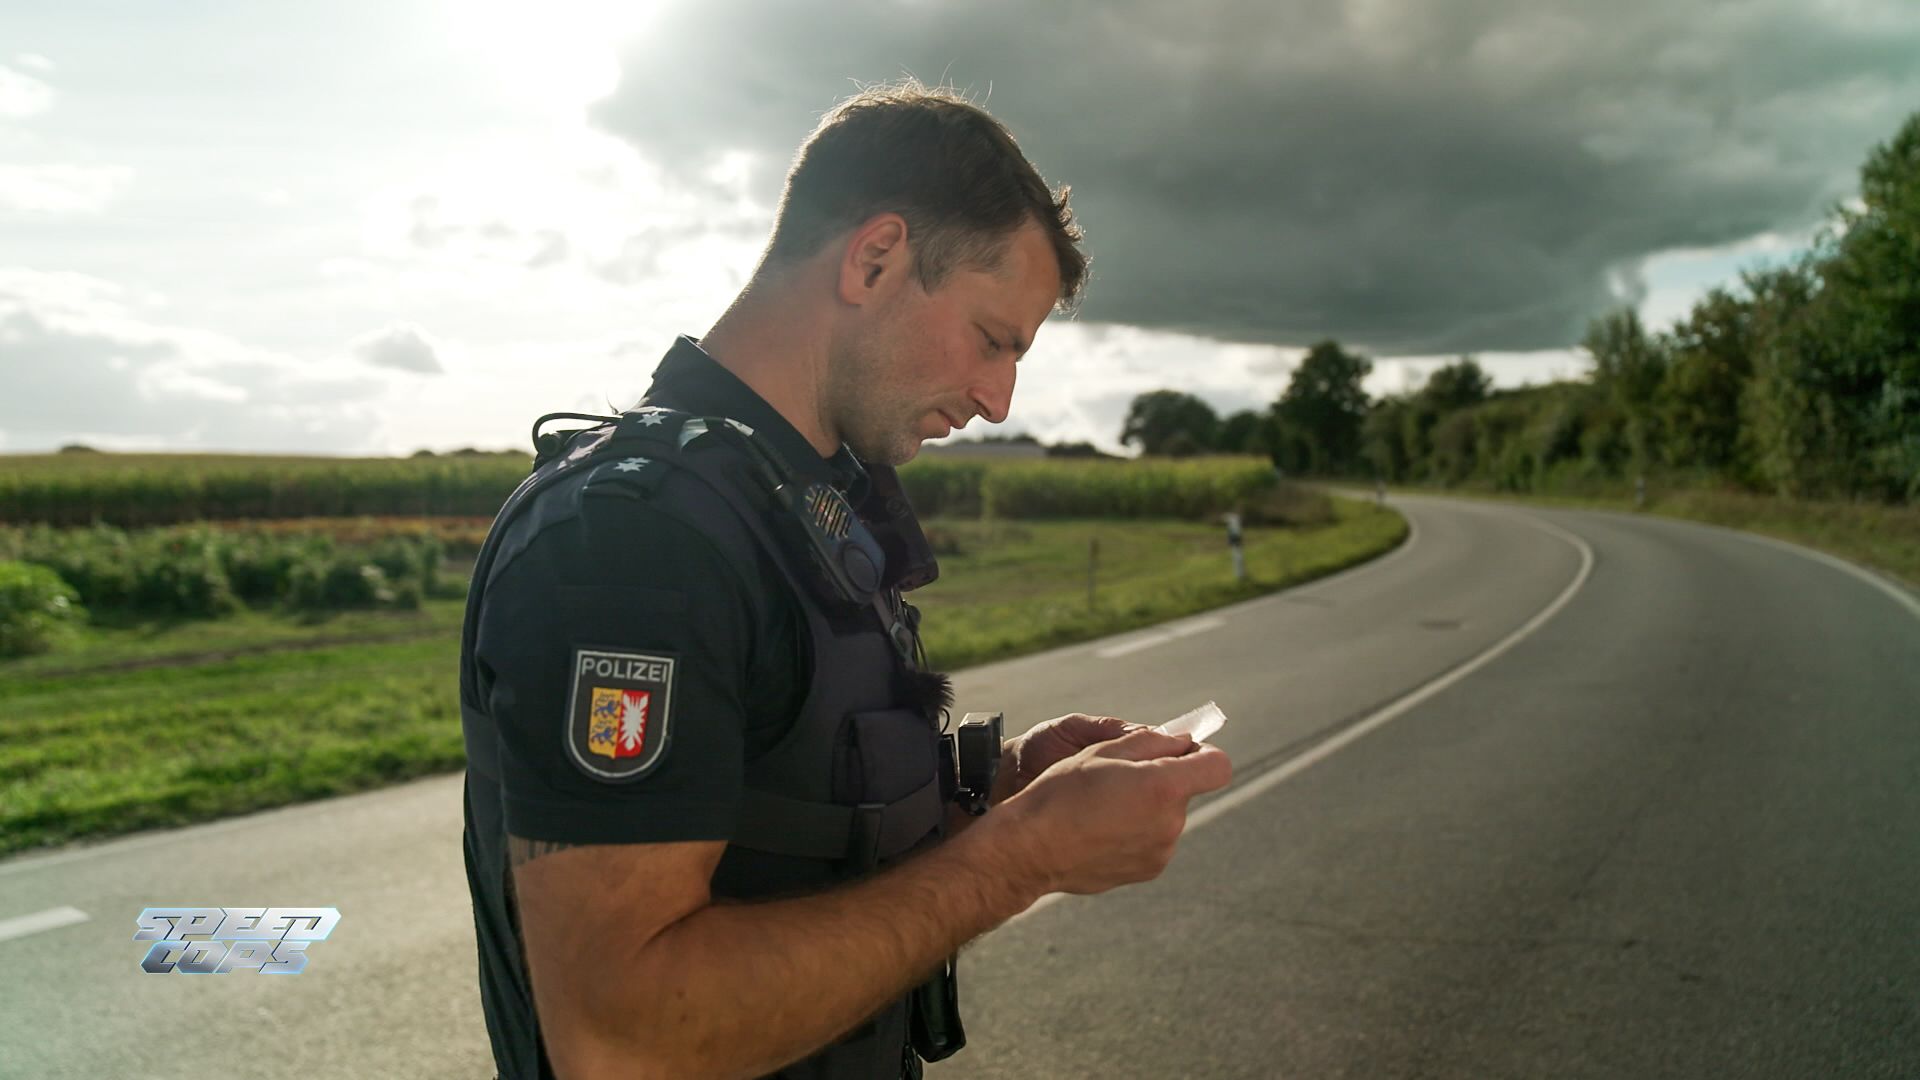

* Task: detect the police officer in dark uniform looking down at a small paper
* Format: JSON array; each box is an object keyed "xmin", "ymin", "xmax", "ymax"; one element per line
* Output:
[{"xmin": 461, "ymin": 83, "xmax": 1231, "ymax": 1080}]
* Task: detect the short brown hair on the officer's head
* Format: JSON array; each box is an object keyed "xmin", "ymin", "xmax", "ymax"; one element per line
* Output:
[{"xmin": 764, "ymin": 79, "xmax": 1087, "ymax": 309}]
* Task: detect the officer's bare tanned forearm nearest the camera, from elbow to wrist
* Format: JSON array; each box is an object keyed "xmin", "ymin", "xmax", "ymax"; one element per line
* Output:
[{"xmin": 572, "ymin": 818, "xmax": 1037, "ymax": 1076}]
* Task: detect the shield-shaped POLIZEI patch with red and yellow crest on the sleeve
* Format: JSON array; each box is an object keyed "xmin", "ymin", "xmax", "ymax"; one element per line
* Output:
[{"xmin": 566, "ymin": 650, "xmax": 678, "ymax": 782}]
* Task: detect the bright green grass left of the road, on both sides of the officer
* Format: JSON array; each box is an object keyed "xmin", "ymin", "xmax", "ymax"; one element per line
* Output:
[{"xmin": 0, "ymin": 500, "xmax": 1405, "ymax": 853}]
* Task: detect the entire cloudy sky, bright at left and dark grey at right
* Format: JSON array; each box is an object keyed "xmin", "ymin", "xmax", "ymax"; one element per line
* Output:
[{"xmin": 0, "ymin": 0, "xmax": 1920, "ymax": 454}]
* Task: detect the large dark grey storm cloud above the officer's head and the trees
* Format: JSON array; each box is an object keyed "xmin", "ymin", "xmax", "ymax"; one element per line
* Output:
[{"xmin": 595, "ymin": 0, "xmax": 1920, "ymax": 354}]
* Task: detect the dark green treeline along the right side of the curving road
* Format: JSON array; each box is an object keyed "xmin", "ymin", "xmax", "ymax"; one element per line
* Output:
[{"xmin": 1121, "ymin": 113, "xmax": 1920, "ymax": 502}]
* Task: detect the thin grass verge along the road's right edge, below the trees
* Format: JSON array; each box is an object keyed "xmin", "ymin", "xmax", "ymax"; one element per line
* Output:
[{"xmin": 1394, "ymin": 484, "xmax": 1920, "ymax": 588}]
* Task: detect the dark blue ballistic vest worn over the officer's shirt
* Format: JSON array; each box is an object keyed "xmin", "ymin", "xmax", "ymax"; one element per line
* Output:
[{"xmin": 461, "ymin": 409, "xmax": 954, "ymax": 1080}]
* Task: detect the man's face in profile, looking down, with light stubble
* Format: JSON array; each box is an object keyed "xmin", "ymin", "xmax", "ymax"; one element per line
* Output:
[{"xmin": 826, "ymin": 221, "xmax": 1060, "ymax": 465}]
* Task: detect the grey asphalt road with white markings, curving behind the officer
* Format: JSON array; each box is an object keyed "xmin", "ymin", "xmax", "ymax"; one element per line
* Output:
[{"xmin": 0, "ymin": 498, "xmax": 1920, "ymax": 1080}]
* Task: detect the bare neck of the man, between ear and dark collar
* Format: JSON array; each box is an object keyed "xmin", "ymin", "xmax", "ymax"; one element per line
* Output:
[{"xmin": 699, "ymin": 286, "xmax": 841, "ymax": 457}]
